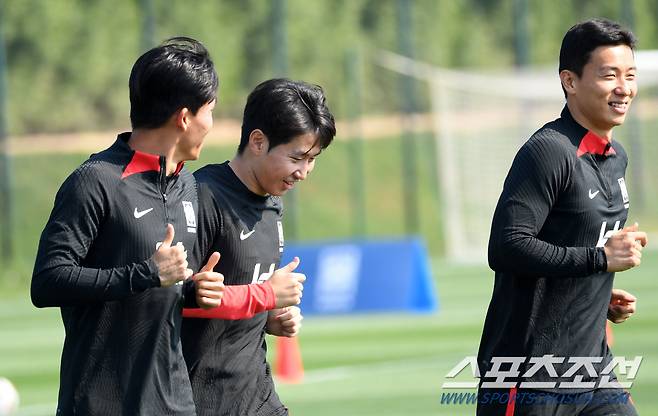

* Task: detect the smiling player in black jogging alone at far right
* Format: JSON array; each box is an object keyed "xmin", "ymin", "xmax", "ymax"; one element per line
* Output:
[{"xmin": 478, "ymin": 19, "xmax": 647, "ymax": 415}]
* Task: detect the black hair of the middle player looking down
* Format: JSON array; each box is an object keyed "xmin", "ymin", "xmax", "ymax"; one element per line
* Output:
[{"xmin": 238, "ymin": 78, "xmax": 336, "ymax": 154}]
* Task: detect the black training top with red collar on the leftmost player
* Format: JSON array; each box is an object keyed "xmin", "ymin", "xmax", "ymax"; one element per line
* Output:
[{"xmin": 32, "ymin": 133, "xmax": 197, "ymax": 416}]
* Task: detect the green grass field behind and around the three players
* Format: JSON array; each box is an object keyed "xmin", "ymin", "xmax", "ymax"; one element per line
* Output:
[{"xmin": 0, "ymin": 136, "xmax": 658, "ymax": 416}]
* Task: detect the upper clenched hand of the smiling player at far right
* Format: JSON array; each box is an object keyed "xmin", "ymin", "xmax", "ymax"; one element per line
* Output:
[{"xmin": 603, "ymin": 223, "xmax": 648, "ymax": 272}]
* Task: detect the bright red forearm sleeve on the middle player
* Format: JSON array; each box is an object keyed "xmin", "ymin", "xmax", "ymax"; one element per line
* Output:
[{"xmin": 183, "ymin": 282, "xmax": 276, "ymax": 320}]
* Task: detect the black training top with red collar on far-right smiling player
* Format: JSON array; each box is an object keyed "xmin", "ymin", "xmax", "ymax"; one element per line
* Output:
[{"xmin": 478, "ymin": 107, "xmax": 629, "ymax": 392}]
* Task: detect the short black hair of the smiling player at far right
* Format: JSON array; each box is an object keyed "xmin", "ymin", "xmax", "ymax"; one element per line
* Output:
[{"xmin": 558, "ymin": 18, "xmax": 637, "ymax": 77}]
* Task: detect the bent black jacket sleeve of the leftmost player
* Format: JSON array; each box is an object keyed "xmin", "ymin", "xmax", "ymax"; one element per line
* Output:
[{"xmin": 31, "ymin": 165, "xmax": 160, "ymax": 307}]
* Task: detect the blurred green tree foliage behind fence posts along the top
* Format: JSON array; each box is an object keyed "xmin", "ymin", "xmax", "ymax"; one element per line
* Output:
[{"xmin": 0, "ymin": 0, "xmax": 658, "ymax": 135}]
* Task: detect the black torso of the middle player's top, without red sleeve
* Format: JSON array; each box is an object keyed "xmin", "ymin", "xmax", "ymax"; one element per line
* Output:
[{"xmin": 182, "ymin": 162, "xmax": 287, "ymax": 416}]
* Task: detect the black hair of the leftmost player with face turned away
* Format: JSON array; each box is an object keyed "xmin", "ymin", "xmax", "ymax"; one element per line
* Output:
[{"xmin": 129, "ymin": 37, "xmax": 219, "ymax": 129}]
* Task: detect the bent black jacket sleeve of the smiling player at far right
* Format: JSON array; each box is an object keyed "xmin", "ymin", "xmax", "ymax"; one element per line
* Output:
[{"xmin": 489, "ymin": 139, "xmax": 606, "ymax": 277}]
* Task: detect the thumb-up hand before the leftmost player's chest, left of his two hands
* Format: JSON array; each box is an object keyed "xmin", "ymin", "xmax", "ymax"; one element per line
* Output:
[{"xmin": 152, "ymin": 224, "xmax": 192, "ymax": 287}]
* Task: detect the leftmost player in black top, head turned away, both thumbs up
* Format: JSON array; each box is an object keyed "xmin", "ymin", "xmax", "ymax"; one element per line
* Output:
[{"xmin": 31, "ymin": 38, "xmax": 223, "ymax": 416}]
